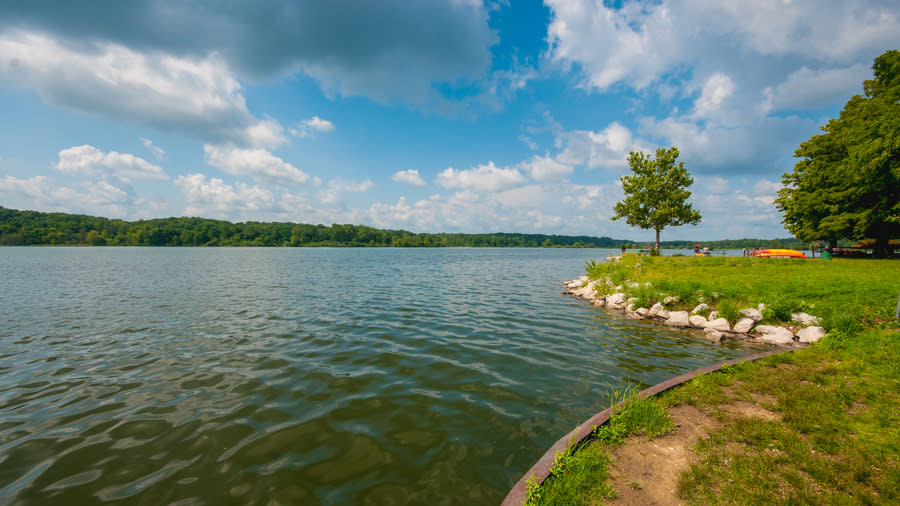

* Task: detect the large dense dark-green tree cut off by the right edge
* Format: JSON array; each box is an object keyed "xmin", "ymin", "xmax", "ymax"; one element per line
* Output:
[{"xmin": 775, "ymin": 50, "xmax": 900, "ymax": 255}]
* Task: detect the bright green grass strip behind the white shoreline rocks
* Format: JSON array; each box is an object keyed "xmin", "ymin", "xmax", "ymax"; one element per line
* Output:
[{"xmin": 586, "ymin": 254, "xmax": 900, "ymax": 329}]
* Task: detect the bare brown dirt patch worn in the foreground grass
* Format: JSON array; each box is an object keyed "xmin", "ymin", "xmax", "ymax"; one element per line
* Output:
[{"xmin": 608, "ymin": 398, "xmax": 778, "ymax": 506}]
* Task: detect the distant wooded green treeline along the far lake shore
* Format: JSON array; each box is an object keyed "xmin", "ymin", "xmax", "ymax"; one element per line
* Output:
[{"xmin": 0, "ymin": 206, "xmax": 803, "ymax": 249}]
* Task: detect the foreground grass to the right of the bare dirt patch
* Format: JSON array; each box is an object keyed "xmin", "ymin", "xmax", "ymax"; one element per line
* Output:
[{"xmin": 660, "ymin": 329, "xmax": 900, "ymax": 505}]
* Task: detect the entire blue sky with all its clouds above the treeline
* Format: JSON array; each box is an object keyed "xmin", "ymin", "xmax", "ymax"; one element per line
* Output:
[{"xmin": 0, "ymin": 0, "xmax": 900, "ymax": 240}]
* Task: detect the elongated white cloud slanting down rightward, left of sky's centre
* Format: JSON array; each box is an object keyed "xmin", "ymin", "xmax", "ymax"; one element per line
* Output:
[{"xmin": 203, "ymin": 144, "xmax": 309, "ymax": 184}]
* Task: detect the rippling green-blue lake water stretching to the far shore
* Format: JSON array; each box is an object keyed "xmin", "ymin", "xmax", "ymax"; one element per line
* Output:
[{"xmin": 0, "ymin": 248, "xmax": 772, "ymax": 505}]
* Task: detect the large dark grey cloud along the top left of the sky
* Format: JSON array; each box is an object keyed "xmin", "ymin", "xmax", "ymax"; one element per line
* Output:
[{"xmin": 0, "ymin": 0, "xmax": 497, "ymax": 105}]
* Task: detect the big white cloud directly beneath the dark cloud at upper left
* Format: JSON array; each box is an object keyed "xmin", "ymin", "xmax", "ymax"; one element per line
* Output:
[{"xmin": 0, "ymin": 30, "xmax": 286, "ymax": 147}]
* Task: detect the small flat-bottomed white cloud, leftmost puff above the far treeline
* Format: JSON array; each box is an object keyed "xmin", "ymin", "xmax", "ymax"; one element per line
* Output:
[{"xmin": 55, "ymin": 144, "xmax": 169, "ymax": 182}]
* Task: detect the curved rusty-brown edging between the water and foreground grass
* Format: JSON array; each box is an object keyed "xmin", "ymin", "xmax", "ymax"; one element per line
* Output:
[{"xmin": 501, "ymin": 349, "xmax": 794, "ymax": 506}]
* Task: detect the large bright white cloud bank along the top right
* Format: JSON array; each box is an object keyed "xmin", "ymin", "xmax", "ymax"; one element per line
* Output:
[{"xmin": 546, "ymin": 0, "xmax": 900, "ymax": 90}]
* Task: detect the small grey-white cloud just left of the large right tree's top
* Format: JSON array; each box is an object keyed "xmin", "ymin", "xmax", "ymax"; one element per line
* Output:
[{"xmin": 761, "ymin": 63, "xmax": 872, "ymax": 113}]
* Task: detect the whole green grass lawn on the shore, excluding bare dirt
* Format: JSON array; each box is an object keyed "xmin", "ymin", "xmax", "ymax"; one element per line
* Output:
[{"xmin": 531, "ymin": 256, "xmax": 900, "ymax": 505}]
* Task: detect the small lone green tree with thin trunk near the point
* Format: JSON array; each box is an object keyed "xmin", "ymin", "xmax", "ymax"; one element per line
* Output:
[{"xmin": 612, "ymin": 146, "xmax": 702, "ymax": 251}]
